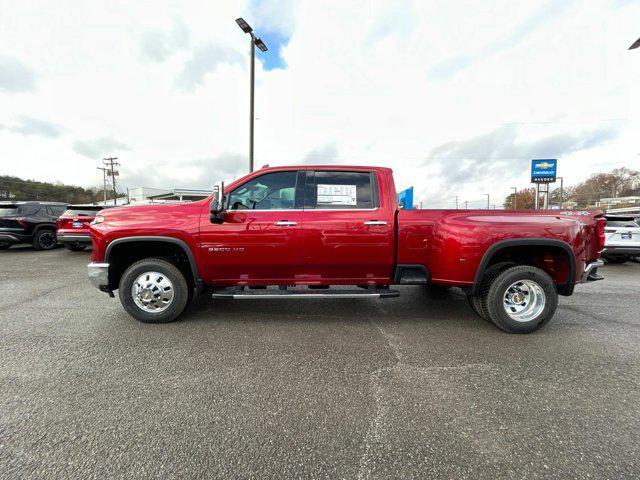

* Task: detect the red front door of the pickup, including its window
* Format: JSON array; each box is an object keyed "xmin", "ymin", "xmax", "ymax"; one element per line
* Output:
[{"xmin": 200, "ymin": 171, "xmax": 304, "ymax": 285}]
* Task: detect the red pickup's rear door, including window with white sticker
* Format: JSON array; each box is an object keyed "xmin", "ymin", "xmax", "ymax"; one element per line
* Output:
[{"xmin": 302, "ymin": 170, "xmax": 395, "ymax": 285}]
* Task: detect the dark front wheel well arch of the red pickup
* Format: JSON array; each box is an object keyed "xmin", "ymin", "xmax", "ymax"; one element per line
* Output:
[{"xmin": 108, "ymin": 240, "xmax": 196, "ymax": 290}]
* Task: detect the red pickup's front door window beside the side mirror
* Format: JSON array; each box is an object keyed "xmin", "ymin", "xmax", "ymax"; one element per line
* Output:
[{"xmin": 228, "ymin": 172, "xmax": 298, "ymax": 210}]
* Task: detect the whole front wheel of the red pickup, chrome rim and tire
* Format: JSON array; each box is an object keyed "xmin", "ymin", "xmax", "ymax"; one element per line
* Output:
[{"xmin": 118, "ymin": 258, "xmax": 189, "ymax": 323}]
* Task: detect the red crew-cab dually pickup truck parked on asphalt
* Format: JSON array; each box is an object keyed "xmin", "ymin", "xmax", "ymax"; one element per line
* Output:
[{"xmin": 88, "ymin": 166, "xmax": 606, "ymax": 333}]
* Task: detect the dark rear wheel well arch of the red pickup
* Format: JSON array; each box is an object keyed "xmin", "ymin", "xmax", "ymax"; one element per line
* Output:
[{"xmin": 474, "ymin": 244, "xmax": 575, "ymax": 295}]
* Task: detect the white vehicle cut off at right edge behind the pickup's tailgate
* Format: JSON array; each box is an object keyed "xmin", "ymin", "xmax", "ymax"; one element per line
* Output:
[{"xmin": 602, "ymin": 215, "xmax": 640, "ymax": 263}]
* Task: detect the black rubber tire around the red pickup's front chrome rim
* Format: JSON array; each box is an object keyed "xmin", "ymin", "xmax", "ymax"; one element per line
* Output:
[{"xmin": 118, "ymin": 258, "xmax": 190, "ymax": 323}]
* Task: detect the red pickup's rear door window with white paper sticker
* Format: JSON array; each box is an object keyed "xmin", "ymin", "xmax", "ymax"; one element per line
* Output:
[{"xmin": 305, "ymin": 171, "xmax": 378, "ymax": 210}]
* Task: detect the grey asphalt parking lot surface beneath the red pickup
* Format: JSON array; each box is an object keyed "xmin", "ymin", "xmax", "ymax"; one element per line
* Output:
[{"xmin": 0, "ymin": 247, "xmax": 640, "ymax": 479}]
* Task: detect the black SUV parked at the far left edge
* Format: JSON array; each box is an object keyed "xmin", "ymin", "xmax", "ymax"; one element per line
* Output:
[{"xmin": 0, "ymin": 202, "xmax": 67, "ymax": 250}]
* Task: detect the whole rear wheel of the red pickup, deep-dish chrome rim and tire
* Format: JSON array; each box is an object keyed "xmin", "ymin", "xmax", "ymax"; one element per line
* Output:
[{"xmin": 482, "ymin": 265, "xmax": 558, "ymax": 333}]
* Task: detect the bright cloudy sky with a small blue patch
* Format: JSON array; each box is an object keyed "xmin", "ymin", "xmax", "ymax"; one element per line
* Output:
[{"xmin": 0, "ymin": 0, "xmax": 640, "ymax": 208}]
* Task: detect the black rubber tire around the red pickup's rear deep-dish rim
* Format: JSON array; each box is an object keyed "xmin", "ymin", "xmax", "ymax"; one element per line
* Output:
[{"xmin": 482, "ymin": 265, "xmax": 558, "ymax": 333}]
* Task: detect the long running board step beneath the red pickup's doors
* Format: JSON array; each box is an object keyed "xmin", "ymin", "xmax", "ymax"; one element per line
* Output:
[{"xmin": 211, "ymin": 288, "xmax": 400, "ymax": 300}]
